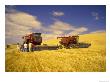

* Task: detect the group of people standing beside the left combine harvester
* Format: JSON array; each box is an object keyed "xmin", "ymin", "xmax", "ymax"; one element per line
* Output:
[{"xmin": 17, "ymin": 42, "xmax": 35, "ymax": 52}]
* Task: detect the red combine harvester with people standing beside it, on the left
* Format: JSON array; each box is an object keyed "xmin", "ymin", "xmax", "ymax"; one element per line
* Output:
[{"xmin": 22, "ymin": 33, "xmax": 58, "ymax": 50}]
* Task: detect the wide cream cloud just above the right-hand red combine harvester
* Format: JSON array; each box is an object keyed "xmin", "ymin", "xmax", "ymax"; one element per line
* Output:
[{"xmin": 50, "ymin": 20, "xmax": 88, "ymax": 35}]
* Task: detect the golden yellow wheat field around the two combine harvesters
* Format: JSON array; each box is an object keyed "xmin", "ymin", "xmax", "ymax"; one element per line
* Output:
[{"xmin": 5, "ymin": 32, "xmax": 106, "ymax": 72}]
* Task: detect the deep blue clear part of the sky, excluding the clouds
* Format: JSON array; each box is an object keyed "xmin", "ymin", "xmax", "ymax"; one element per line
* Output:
[{"xmin": 16, "ymin": 5, "xmax": 106, "ymax": 31}]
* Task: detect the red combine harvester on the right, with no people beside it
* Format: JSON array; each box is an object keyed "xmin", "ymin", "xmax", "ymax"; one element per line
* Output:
[{"xmin": 57, "ymin": 35, "xmax": 91, "ymax": 48}]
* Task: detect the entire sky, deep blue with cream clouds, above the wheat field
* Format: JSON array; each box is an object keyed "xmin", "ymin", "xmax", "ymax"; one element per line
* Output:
[{"xmin": 5, "ymin": 5, "xmax": 106, "ymax": 42}]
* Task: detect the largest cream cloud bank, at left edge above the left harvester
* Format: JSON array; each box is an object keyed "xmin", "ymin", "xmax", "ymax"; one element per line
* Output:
[{"xmin": 5, "ymin": 9, "xmax": 42, "ymax": 43}]
